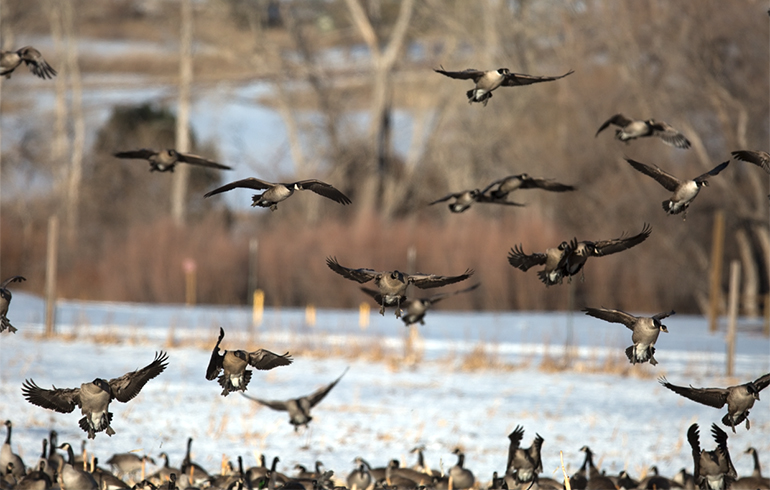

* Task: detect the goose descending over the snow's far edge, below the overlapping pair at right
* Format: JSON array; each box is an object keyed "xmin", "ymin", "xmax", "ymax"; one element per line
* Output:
[{"xmin": 583, "ymin": 308, "xmax": 676, "ymax": 366}]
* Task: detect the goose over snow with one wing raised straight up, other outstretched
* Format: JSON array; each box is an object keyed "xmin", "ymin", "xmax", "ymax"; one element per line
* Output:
[{"xmin": 206, "ymin": 327, "xmax": 294, "ymax": 396}]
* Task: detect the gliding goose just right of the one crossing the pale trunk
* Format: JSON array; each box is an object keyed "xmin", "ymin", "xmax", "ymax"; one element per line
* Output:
[{"xmin": 203, "ymin": 177, "xmax": 352, "ymax": 211}]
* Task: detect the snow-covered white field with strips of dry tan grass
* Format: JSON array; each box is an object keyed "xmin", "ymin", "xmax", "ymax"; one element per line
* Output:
[{"xmin": 0, "ymin": 293, "xmax": 770, "ymax": 482}]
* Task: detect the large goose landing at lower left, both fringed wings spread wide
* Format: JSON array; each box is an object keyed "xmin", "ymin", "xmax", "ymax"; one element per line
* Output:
[{"xmin": 21, "ymin": 351, "xmax": 168, "ymax": 439}]
